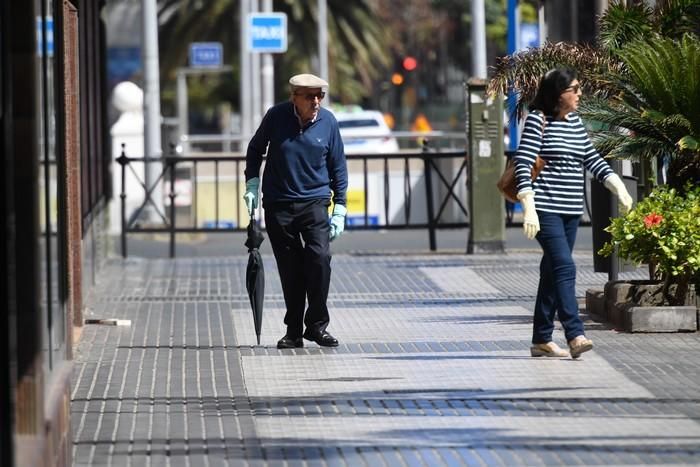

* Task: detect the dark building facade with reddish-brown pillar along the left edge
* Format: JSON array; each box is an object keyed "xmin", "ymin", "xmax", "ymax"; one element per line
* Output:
[{"xmin": 0, "ymin": 0, "xmax": 111, "ymax": 467}]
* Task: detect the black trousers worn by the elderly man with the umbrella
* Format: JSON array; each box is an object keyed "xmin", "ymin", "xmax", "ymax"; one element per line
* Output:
[{"xmin": 265, "ymin": 199, "xmax": 331, "ymax": 337}]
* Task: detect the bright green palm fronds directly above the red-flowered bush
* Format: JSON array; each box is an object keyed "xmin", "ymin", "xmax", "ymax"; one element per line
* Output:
[{"xmin": 580, "ymin": 34, "xmax": 700, "ymax": 190}]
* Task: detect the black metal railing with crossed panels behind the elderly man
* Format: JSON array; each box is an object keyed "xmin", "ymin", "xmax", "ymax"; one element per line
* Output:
[{"xmin": 116, "ymin": 141, "xmax": 469, "ymax": 257}]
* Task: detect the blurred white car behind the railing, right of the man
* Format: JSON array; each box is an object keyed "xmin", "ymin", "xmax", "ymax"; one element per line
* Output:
[{"xmin": 334, "ymin": 110, "xmax": 399, "ymax": 154}]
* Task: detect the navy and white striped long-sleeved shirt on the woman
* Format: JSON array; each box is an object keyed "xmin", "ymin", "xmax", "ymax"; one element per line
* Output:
[{"xmin": 515, "ymin": 112, "xmax": 613, "ymax": 215}]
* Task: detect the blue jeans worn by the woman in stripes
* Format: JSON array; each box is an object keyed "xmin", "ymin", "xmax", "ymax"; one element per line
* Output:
[{"xmin": 532, "ymin": 211, "xmax": 583, "ymax": 344}]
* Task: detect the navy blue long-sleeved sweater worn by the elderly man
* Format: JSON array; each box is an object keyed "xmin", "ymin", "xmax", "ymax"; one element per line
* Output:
[{"xmin": 245, "ymin": 102, "xmax": 348, "ymax": 205}]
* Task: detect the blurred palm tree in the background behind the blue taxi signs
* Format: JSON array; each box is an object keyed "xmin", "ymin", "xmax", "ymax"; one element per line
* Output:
[{"xmin": 158, "ymin": 0, "xmax": 389, "ymax": 104}]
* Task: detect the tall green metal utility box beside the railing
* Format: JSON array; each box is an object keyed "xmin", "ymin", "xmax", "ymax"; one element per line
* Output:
[{"xmin": 465, "ymin": 79, "xmax": 506, "ymax": 253}]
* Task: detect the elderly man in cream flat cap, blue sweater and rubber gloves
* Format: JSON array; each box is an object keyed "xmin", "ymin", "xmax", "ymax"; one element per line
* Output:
[{"xmin": 243, "ymin": 73, "xmax": 348, "ymax": 349}]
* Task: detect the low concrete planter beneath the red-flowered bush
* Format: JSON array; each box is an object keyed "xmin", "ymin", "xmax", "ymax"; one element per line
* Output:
[{"xmin": 586, "ymin": 281, "xmax": 700, "ymax": 332}]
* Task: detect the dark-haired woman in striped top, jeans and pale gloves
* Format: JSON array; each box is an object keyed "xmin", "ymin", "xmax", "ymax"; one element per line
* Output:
[{"xmin": 515, "ymin": 68, "xmax": 632, "ymax": 358}]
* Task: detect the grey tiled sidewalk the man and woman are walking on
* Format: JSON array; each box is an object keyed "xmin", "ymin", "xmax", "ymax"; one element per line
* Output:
[{"xmin": 72, "ymin": 245, "xmax": 700, "ymax": 467}]
